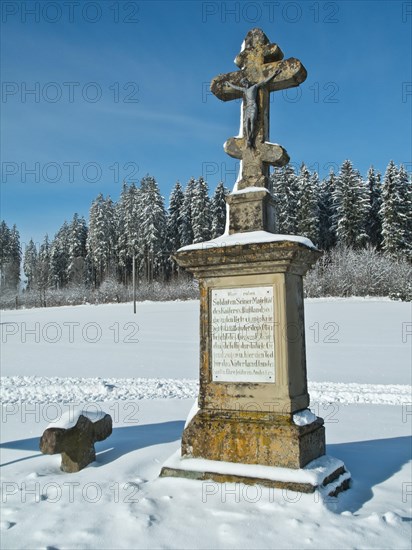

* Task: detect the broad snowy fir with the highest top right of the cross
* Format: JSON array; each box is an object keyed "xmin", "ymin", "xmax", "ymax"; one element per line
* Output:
[{"xmin": 333, "ymin": 160, "xmax": 369, "ymax": 248}]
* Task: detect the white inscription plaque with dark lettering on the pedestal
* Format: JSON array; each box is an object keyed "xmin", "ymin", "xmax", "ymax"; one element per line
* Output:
[{"xmin": 210, "ymin": 286, "xmax": 275, "ymax": 383}]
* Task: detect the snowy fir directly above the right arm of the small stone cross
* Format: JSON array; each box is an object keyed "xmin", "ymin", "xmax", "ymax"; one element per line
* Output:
[{"xmin": 86, "ymin": 193, "xmax": 116, "ymax": 286}]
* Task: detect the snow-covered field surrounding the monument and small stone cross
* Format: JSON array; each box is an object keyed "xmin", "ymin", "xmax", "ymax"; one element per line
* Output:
[{"xmin": 0, "ymin": 299, "xmax": 412, "ymax": 549}]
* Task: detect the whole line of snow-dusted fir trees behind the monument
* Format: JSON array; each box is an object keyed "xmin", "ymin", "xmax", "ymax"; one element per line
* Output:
[{"xmin": 0, "ymin": 160, "xmax": 412, "ymax": 295}]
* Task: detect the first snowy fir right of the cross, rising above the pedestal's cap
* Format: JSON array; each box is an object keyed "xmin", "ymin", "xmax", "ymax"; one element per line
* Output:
[{"xmin": 271, "ymin": 164, "xmax": 299, "ymax": 235}]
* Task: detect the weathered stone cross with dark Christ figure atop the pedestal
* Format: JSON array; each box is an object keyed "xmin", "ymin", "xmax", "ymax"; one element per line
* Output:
[{"xmin": 210, "ymin": 29, "xmax": 307, "ymax": 190}]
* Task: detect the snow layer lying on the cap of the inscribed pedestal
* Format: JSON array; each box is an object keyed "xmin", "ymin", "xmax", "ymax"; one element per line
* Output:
[{"xmin": 178, "ymin": 231, "xmax": 316, "ymax": 252}]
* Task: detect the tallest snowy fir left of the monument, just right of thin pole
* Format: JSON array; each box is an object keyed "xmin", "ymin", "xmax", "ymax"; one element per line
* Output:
[{"xmin": 139, "ymin": 175, "xmax": 167, "ymax": 282}]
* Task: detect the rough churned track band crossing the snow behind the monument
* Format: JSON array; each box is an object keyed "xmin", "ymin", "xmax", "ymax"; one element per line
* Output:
[{"xmin": 0, "ymin": 376, "xmax": 412, "ymax": 405}]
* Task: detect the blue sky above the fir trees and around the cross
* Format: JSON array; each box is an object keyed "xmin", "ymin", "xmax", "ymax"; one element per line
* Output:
[{"xmin": 1, "ymin": 0, "xmax": 412, "ymax": 248}]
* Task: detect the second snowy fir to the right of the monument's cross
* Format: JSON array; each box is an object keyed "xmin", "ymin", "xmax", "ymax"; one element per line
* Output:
[{"xmin": 297, "ymin": 164, "xmax": 319, "ymax": 244}]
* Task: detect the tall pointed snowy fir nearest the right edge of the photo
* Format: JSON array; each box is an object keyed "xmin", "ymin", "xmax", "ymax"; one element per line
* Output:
[{"xmin": 380, "ymin": 160, "xmax": 408, "ymax": 254}]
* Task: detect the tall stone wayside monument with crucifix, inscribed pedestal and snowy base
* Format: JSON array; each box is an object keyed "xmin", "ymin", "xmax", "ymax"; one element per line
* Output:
[{"xmin": 161, "ymin": 29, "xmax": 350, "ymax": 495}]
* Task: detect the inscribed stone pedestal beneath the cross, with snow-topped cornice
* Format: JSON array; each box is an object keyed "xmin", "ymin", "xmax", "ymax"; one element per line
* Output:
[{"xmin": 161, "ymin": 237, "xmax": 350, "ymax": 496}]
